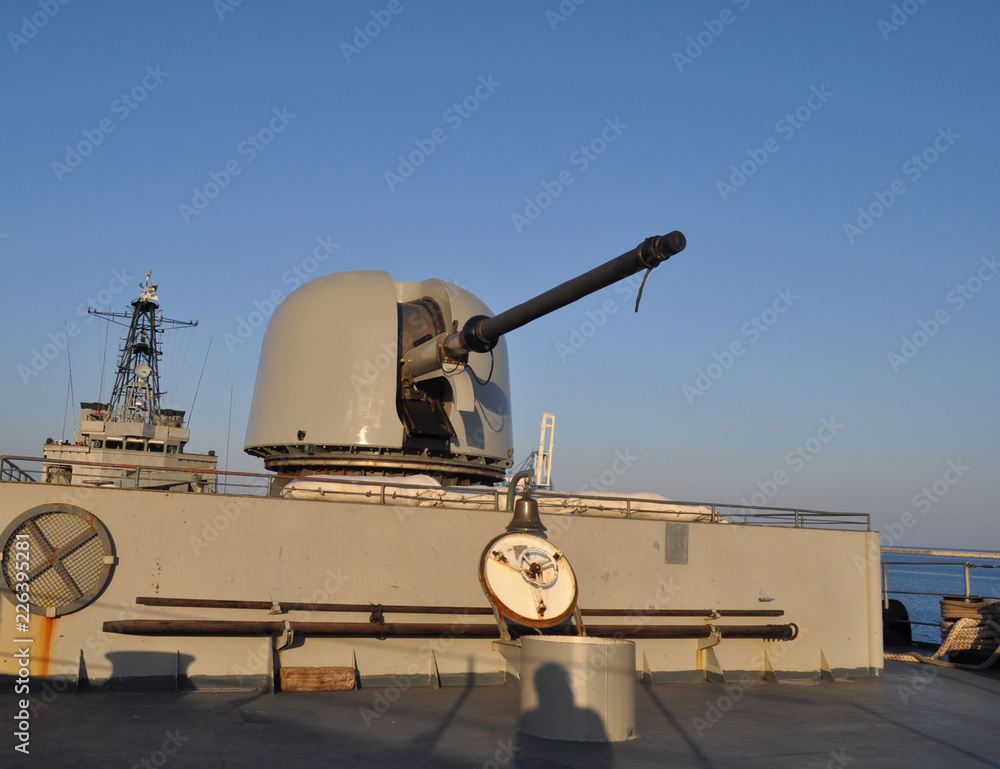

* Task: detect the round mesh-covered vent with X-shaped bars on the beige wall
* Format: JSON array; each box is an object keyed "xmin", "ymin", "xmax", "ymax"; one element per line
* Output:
[{"xmin": 0, "ymin": 504, "xmax": 115, "ymax": 617}]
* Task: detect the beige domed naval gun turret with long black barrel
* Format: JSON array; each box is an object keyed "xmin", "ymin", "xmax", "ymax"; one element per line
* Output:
[{"xmin": 244, "ymin": 231, "xmax": 686, "ymax": 485}]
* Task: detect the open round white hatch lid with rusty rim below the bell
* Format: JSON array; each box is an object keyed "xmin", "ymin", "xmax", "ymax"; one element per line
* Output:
[{"xmin": 479, "ymin": 532, "xmax": 577, "ymax": 628}]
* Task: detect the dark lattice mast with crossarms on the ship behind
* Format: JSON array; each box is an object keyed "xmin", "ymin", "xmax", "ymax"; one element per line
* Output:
[{"xmin": 87, "ymin": 270, "xmax": 198, "ymax": 425}]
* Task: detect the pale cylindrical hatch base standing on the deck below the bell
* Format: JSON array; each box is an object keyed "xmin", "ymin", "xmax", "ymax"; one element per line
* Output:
[{"xmin": 518, "ymin": 636, "xmax": 636, "ymax": 742}]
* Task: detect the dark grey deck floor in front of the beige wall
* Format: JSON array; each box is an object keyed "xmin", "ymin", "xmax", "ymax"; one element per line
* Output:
[{"xmin": 7, "ymin": 662, "xmax": 1000, "ymax": 769}]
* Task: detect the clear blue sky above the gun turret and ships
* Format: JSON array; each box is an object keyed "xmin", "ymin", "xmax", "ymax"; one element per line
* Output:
[{"xmin": 0, "ymin": 0, "xmax": 1000, "ymax": 549}]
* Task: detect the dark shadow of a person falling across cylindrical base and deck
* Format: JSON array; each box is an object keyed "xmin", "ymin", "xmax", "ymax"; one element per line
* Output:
[{"xmin": 514, "ymin": 662, "xmax": 614, "ymax": 769}]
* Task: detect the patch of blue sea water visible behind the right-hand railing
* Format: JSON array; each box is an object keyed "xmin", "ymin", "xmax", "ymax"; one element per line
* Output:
[{"xmin": 882, "ymin": 553, "xmax": 1000, "ymax": 644}]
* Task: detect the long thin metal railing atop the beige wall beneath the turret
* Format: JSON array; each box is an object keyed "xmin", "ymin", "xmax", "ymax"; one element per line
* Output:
[{"xmin": 0, "ymin": 456, "xmax": 871, "ymax": 531}]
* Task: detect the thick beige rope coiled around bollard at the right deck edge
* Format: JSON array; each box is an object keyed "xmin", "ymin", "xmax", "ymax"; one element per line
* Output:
[{"xmin": 885, "ymin": 598, "xmax": 1000, "ymax": 670}]
